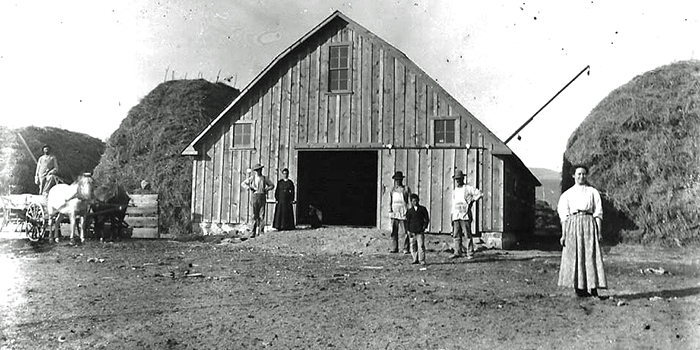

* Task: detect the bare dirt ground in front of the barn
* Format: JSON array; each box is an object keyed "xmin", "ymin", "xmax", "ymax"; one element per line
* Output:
[{"xmin": 0, "ymin": 227, "xmax": 700, "ymax": 349}]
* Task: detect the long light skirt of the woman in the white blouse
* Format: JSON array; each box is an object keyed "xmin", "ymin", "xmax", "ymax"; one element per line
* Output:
[{"xmin": 558, "ymin": 214, "xmax": 608, "ymax": 290}]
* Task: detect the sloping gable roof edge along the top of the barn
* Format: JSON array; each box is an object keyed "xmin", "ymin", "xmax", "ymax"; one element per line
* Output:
[{"xmin": 182, "ymin": 11, "xmax": 513, "ymax": 156}]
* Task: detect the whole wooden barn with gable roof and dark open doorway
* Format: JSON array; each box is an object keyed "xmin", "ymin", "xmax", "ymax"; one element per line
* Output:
[{"xmin": 182, "ymin": 12, "xmax": 540, "ymax": 247}]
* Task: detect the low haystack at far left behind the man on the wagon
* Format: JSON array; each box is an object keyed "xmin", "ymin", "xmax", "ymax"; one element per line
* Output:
[{"xmin": 0, "ymin": 126, "xmax": 105, "ymax": 195}]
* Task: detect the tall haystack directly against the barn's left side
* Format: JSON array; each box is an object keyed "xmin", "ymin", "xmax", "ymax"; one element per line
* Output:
[{"xmin": 95, "ymin": 79, "xmax": 239, "ymax": 235}]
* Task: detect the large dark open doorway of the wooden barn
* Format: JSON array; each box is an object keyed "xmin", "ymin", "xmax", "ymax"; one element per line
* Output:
[{"xmin": 297, "ymin": 151, "xmax": 378, "ymax": 226}]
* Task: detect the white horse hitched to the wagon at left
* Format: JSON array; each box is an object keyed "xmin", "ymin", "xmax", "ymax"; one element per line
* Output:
[{"xmin": 47, "ymin": 173, "xmax": 93, "ymax": 242}]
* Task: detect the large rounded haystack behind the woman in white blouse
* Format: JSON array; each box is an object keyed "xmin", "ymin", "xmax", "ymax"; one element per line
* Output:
[{"xmin": 562, "ymin": 60, "xmax": 700, "ymax": 245}]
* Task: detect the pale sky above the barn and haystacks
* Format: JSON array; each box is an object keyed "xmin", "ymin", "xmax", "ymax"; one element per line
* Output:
[{"xmin": 0, "ymin": 0, "xmax": 700, "ymax": 171}]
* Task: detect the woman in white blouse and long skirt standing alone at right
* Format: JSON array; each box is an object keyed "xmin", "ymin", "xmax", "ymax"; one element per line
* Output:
[{"xmin": 557, "ymin": 165, "xmax": 607, "ymax": 297}]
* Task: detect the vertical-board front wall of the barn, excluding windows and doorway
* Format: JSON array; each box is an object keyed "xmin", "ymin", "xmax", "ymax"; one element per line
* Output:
[{"xmin": 192, "ymin": 21, "xmax": 528, "ymax": 238}]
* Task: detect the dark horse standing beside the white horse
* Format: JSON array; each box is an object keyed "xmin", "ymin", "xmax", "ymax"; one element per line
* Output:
[{"xmin": 90, "ymin": 183, "xmax": 131, "ymax": 241}]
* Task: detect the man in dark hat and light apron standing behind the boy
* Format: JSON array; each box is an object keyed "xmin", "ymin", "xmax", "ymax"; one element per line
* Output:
[{"xmin": 389, "ymin": 171, "xmax": 411, "ymax": 254}]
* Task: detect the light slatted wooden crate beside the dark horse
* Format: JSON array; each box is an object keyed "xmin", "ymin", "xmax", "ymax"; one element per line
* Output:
[{"xmin": 124, "ymin": 194, "xmax": 160, "ymax": 238}]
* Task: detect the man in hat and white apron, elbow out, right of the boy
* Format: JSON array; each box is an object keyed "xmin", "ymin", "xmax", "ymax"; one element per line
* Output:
[{"xmin": 450, "ymin": 170, "xmax": 484, "ymax": 259}]
